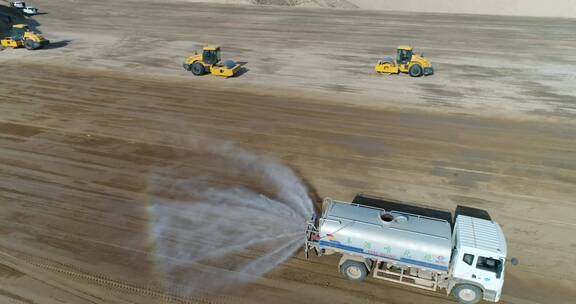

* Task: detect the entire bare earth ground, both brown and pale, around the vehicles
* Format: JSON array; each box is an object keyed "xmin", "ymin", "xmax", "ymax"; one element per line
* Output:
[{"xmin": 0, "ymin": 0, "xmax": 576, "ymax": 304}]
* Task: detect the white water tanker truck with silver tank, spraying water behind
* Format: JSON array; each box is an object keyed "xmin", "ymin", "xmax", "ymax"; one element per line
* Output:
[{"xmin": 305, "ymin": 196, "xmax": 517, "ymax": 304}]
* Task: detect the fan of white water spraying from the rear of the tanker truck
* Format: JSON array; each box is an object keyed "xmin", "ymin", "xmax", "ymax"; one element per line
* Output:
[{"xmin": 149, "ymin": 142, "xmax": 314, "ymax": 295}]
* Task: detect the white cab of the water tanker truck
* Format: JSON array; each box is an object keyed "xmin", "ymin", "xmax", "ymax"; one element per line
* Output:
[{"xmin": 447, "ymin": 215, "xmax": 507, "ymax": 303}]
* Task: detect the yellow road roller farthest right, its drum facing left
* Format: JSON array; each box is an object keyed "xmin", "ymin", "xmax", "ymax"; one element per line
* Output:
[{"xmin": 374, "ymin": 45, "xmax": 434, "ymax": 77}]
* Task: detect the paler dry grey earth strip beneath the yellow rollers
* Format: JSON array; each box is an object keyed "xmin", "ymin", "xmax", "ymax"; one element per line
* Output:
[{"xmin": 0, "ymin": 0, "xmax": 576, "ymax": 117}]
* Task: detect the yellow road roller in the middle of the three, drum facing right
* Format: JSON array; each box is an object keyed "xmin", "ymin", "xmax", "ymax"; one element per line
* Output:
[{"xmin": 183, "ymin": 46, "xmax": 240, "ymax": 78}]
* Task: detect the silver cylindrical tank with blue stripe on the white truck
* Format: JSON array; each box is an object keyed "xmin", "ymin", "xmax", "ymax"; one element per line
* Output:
[{"xmin": 318, "ymin": 200, "xmax": 452, "ymax": 271}]
